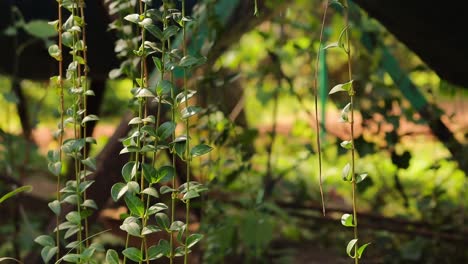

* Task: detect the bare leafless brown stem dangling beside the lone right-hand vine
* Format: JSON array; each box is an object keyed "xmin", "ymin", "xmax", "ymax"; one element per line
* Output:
[{"xmin": 314, "ymin": 2, "xmax": 328, "ymax": 215}]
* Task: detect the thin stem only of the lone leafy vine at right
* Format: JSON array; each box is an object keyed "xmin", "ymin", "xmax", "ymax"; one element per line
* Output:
[{"xmin": 344, "ymin": 0, "xmax": 359, "ymax": 264}]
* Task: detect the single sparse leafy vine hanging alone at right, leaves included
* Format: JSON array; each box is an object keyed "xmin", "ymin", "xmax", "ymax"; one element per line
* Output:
[{"xmin": 325, "ymin": 0, "xmax": 370, "ymax": 264}]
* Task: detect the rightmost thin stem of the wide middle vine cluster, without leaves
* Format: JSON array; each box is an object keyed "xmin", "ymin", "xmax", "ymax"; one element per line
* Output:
[{"xmin": 182, "ymin": 0, "xmax": 191, "ymax": 264}]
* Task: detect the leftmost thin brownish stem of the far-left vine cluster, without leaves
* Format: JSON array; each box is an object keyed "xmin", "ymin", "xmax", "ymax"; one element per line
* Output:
[{"xmin": 55, "ymin": 0, "xmax": 65, "ymax": 261}]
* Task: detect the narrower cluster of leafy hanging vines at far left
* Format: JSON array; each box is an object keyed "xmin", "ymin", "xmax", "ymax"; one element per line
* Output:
[{"xmin": 35, "ymin": 0, "xmax": 101, "ymax": 263}]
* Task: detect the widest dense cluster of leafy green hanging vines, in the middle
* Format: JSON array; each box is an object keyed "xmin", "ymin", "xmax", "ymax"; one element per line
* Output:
[{"xmin": 106, "ymin": 1, "xmax": 211, "ymax": 263}]
